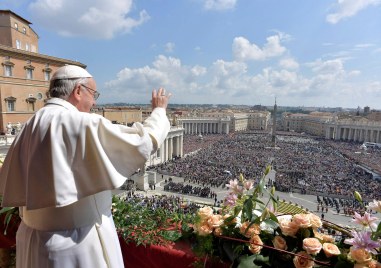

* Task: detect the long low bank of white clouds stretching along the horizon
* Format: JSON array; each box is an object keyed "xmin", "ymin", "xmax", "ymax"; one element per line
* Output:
[{"xmin": 102, "ymin": 46, "xmax": 381, "ymax": 107}]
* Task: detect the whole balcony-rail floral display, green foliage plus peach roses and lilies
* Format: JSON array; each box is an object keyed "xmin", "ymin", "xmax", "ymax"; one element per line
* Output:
[{"xmin": 1, "ymin": 161, "xmax": 381, "ymax": 268}]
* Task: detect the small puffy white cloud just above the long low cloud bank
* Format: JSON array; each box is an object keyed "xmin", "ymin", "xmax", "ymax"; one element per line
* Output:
[{"xmin": 232, "ymin": 35, "xmax": 286, "ymax": 61}]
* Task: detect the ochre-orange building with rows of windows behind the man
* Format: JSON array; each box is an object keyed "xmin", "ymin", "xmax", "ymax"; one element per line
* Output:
[{"xmin": 0, "ymin": 10, "xmax": 86, "ymax": 134}]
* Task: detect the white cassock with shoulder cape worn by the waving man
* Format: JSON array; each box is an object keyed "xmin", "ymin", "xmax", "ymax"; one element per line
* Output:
[{"xmin": 0, "ymin": 98, "xmax": 170, "ymax": 268}]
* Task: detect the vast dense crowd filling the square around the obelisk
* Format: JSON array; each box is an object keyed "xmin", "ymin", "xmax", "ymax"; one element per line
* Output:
[{"xmin": 152, "ymin": 132, "xmax": 381, "ymax": 200}]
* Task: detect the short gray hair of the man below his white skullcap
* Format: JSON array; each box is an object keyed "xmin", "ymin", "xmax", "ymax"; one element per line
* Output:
[{"xmin": 48, "ymin": 78, "xmax": 87, "ymax": 100}]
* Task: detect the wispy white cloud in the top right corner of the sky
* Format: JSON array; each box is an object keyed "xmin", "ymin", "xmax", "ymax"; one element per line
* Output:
[{"xmin": 326, "ymin": 0, "xmax": 381, "ymax": 24}]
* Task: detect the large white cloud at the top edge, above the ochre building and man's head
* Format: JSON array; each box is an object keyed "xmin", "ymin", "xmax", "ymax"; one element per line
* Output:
[{"xmin": 29, "ymin": 0, "xmax": 149, "ymax": 39}]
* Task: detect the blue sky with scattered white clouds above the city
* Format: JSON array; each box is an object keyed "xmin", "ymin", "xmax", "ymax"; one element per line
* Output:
[{"xmin": 0, "ymin": 0, "xmax": 381, "ymax": 110}]
